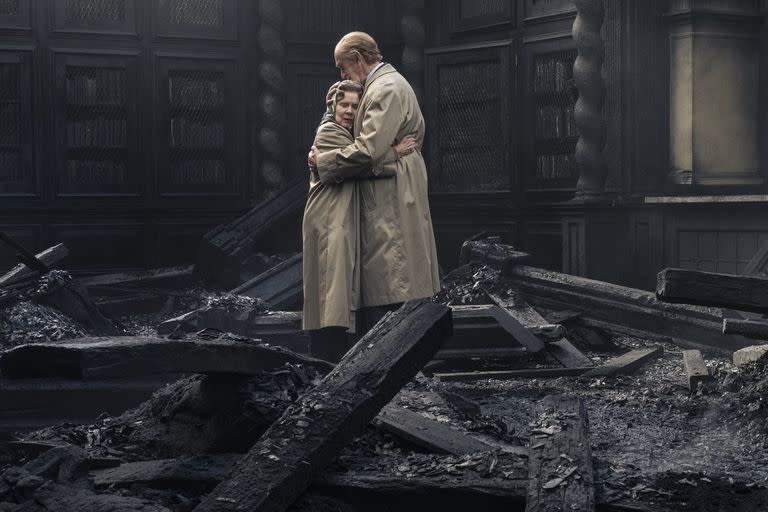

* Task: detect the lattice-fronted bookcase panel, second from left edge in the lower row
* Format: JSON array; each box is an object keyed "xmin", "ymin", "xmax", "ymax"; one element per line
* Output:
[{"xmin": 65, "ymin": 66, "xmax": 128, "ymax": 191}]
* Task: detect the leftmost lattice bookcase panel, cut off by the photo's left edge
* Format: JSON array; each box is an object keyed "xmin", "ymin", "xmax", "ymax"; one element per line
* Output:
[{"xmin": 0, "ymin": 64, "xmax": 23, "ymax": 183}]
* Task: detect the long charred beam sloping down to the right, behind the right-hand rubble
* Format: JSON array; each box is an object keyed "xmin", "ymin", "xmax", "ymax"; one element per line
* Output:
[{"xmin": 504, "ymin": 265, "xmax": 751, "ymax": 356}]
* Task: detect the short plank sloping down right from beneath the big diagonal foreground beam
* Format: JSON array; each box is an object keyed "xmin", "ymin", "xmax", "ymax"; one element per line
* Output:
[{"xmin": 373, "ymin": 404, "xmax": 491, "ymax": 455}]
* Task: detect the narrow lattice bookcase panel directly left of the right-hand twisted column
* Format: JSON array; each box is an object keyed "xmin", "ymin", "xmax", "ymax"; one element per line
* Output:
[{"xmin": 533, "ymin": 50, "xmax": 578, "ymax": 184}]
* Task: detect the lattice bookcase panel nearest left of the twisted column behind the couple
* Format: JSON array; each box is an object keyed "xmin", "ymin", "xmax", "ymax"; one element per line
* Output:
[{"xmin": 168, "ymin": 71, "xmax": 233, "ymax": 186}]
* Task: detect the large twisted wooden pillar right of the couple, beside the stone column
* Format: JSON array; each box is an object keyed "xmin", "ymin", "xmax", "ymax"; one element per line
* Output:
[{"xmin": 573, "ymin": 0, "xmax": 607, "ymax": 202}]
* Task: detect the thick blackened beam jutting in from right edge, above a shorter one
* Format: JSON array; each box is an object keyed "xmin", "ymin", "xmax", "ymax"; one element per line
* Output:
[{"xmin": 656, "ymin": 268, "xmax": 768, "ymax": 313}]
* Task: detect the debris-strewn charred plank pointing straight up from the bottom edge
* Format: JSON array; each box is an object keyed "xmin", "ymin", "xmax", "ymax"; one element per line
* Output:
[{"xmin": 525, "ymin": 395, "xmax": 595, "ymax": 512}]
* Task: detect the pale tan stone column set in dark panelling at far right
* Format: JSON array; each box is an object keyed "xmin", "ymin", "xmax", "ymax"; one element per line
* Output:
[{"xmin": 668, "ymin": 0, "xmax": 763, "ymax": 191}]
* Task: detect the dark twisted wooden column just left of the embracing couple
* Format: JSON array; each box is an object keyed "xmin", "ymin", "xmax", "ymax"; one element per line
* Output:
[{"xmin": 258, "ymin": 0, "xmax": 287, "ymax": 197}]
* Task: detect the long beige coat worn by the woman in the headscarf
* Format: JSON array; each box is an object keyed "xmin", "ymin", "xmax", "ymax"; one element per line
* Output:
[{"xmin": 302, "ymin": 118, "xmax": 396, "ymax": 332}]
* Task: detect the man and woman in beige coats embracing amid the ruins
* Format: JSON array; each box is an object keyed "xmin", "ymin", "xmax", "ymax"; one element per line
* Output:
[{"xmin": 302, "ymin": 32, "xmax": 440, "ymax": 361}]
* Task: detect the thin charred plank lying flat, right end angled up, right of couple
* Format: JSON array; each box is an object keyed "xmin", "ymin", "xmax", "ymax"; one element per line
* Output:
[{"xmin": 433, "ymin": 347, "xmax": 664, "ymax": 382}]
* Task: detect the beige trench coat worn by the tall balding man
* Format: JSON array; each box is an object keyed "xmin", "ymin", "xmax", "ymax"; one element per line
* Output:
[{"xmin": 317, "ymin": 64, "xmax": 440, "ymax": 307}]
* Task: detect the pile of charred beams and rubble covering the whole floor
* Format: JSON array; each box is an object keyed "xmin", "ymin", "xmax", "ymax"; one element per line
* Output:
[{"xmin": 0, "ymin": 217, "xmax": 768, "ymax": 512}]
